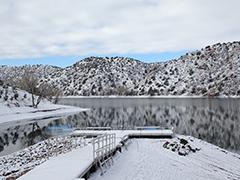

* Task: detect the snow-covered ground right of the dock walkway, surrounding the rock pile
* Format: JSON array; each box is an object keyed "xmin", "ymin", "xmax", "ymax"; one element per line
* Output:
[{"xmin": 90, "ymin": 136, "xmax": 240, "ymax": 180}]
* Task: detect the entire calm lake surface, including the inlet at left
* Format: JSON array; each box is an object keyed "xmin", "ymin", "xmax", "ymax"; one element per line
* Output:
[{"xmin": 0, "ymin": 98, "xmax": 240, "ymax": 156}]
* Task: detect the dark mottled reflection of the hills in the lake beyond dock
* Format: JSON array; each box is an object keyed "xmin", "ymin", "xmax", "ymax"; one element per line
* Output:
[{"xmin": 60, "ymin": 99, "xmax": 240, "ymax": 150}]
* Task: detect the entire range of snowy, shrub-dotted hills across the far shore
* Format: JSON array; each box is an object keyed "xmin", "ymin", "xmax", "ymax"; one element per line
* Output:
[{"xmin": 0, "ymin": 42, "xmax": 240, "ymax": 96}]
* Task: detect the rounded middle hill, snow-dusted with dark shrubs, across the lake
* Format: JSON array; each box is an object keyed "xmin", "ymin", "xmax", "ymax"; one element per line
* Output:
[{"xmin": 42, "ymin": 57, "xmax": 152, "ymax": 96}]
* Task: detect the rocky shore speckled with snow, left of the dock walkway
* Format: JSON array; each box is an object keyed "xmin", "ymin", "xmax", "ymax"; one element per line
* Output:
[{"xmin": 0, "ymin": 136, "xmax": 88, "ymax": 179}]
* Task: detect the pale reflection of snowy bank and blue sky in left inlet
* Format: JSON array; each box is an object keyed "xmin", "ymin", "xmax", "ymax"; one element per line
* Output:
[{"xmin": 0, "ymin": 118, "xmax": 73, "ymax": 156}]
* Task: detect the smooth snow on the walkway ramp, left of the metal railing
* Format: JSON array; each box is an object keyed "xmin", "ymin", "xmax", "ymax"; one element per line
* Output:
[{"xmin": 19, "ymin": 145, "xmax": 93, "ymax": 180}]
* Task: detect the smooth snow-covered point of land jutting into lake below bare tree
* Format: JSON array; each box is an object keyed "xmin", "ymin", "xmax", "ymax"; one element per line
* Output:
[{"xmin": 0, "ymin": 85, "xmax": 86, "ymax": 124}]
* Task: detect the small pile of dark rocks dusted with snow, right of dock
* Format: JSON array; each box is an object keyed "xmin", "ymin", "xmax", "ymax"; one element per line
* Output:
[{"xmin": 163, "ymin": 138, "xmax": 200, "ymax": 156}]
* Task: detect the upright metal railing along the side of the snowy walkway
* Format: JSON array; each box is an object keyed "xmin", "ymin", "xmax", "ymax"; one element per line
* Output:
[{"xmin": 92, "ymin": 133, "xmax": 116, "ymax": 175}]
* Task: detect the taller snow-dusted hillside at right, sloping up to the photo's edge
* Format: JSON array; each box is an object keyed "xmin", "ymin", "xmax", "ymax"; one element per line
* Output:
[{"xmin": 139, "ymin": 42, "xmax": 240, "ymax": 96}]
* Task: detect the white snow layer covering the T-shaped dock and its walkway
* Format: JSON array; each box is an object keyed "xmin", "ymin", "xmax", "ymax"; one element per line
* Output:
[{"xmin": 19, "ymin": 129, "xmax": 174, "ymax": 180}]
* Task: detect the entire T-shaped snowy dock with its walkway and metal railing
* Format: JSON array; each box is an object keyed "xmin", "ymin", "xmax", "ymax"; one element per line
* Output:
[{"xmin": 19, "ymin": 128, "xmax": 174, "ymax": 180}]
